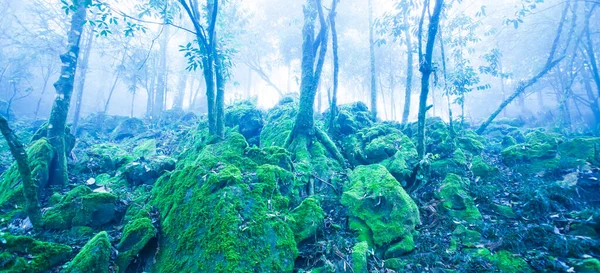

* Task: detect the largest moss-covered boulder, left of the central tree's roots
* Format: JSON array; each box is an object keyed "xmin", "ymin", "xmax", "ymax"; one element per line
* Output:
[{"xmin": 151, "ymin": 133, "xmax": 298, "ymax": 273}]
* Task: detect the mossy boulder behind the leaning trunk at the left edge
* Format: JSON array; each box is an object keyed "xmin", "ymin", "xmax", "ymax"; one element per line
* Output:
[{"xmin": 0, "ymin": 138, "xmax": 54, "ymax": 213}]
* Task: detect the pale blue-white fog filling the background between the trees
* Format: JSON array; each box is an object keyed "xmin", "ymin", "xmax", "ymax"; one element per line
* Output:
[{"xmin": 0, "ymin": 0, "xmax": 600, "ymax": 127}]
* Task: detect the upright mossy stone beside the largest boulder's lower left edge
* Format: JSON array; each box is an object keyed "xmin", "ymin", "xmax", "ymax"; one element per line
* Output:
[{"xmin": 117, "ymin": 218, "xmax": 157, "ymax": 272}]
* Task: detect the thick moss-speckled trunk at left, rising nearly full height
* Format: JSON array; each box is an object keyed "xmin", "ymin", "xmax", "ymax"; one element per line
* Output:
[{"xmin": 48, "ymin": 5, "xmax": 86, "ymax": 187}]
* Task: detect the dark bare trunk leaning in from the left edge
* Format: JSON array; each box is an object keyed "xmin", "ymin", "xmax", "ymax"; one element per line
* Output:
[{"xmin": 0, "ymin": 115, "xmax": 42, "ymax": 229}]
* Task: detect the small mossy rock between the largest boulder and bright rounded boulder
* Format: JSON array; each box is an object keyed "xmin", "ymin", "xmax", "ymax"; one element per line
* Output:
[{"xmin": 291, "ymin": 198, "xmax": 325, "ymax": 243}]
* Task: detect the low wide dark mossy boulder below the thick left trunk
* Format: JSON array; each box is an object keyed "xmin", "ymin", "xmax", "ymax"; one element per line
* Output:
[{"xmin": 43, "ymin": 186, "xmax": 117, "ymax": 230}]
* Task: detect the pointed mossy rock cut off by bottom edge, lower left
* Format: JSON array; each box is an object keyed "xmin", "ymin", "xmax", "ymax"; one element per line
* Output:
[{"xmin": 64, "ymin": 231, "xmax": 111, "ymax": 273}]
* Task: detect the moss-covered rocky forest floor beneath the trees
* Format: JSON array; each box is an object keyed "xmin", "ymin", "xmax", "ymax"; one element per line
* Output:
[{"xmin": 0, "ymin": 98, "xmax": 600, "ymax": 273}]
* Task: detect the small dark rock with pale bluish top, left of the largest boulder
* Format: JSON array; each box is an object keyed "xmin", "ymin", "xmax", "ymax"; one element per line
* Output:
[{"xmin": 123, "ymin": 156, "xmax": 176, "ymax": 186}]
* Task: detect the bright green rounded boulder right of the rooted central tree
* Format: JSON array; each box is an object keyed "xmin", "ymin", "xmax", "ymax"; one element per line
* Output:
[{"xmin": 342, "ymin": 164, "xmax": 420, "ymax": 255}]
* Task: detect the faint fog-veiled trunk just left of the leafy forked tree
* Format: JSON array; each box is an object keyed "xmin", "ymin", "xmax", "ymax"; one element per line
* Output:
[{"xmin": 152, "ymin": 25, "xmax": 169, "ymax": 119}]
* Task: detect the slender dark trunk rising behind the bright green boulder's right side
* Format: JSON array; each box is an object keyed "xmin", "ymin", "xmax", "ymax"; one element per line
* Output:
[{"xmin": 417, "ymin": 0, "xmax": 444, "ymax": 159}]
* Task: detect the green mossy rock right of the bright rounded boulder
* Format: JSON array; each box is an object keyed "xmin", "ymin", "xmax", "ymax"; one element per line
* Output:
[{"xmin": 437, "ymin": 173, "xmax": 482, "ymax": 224}]
